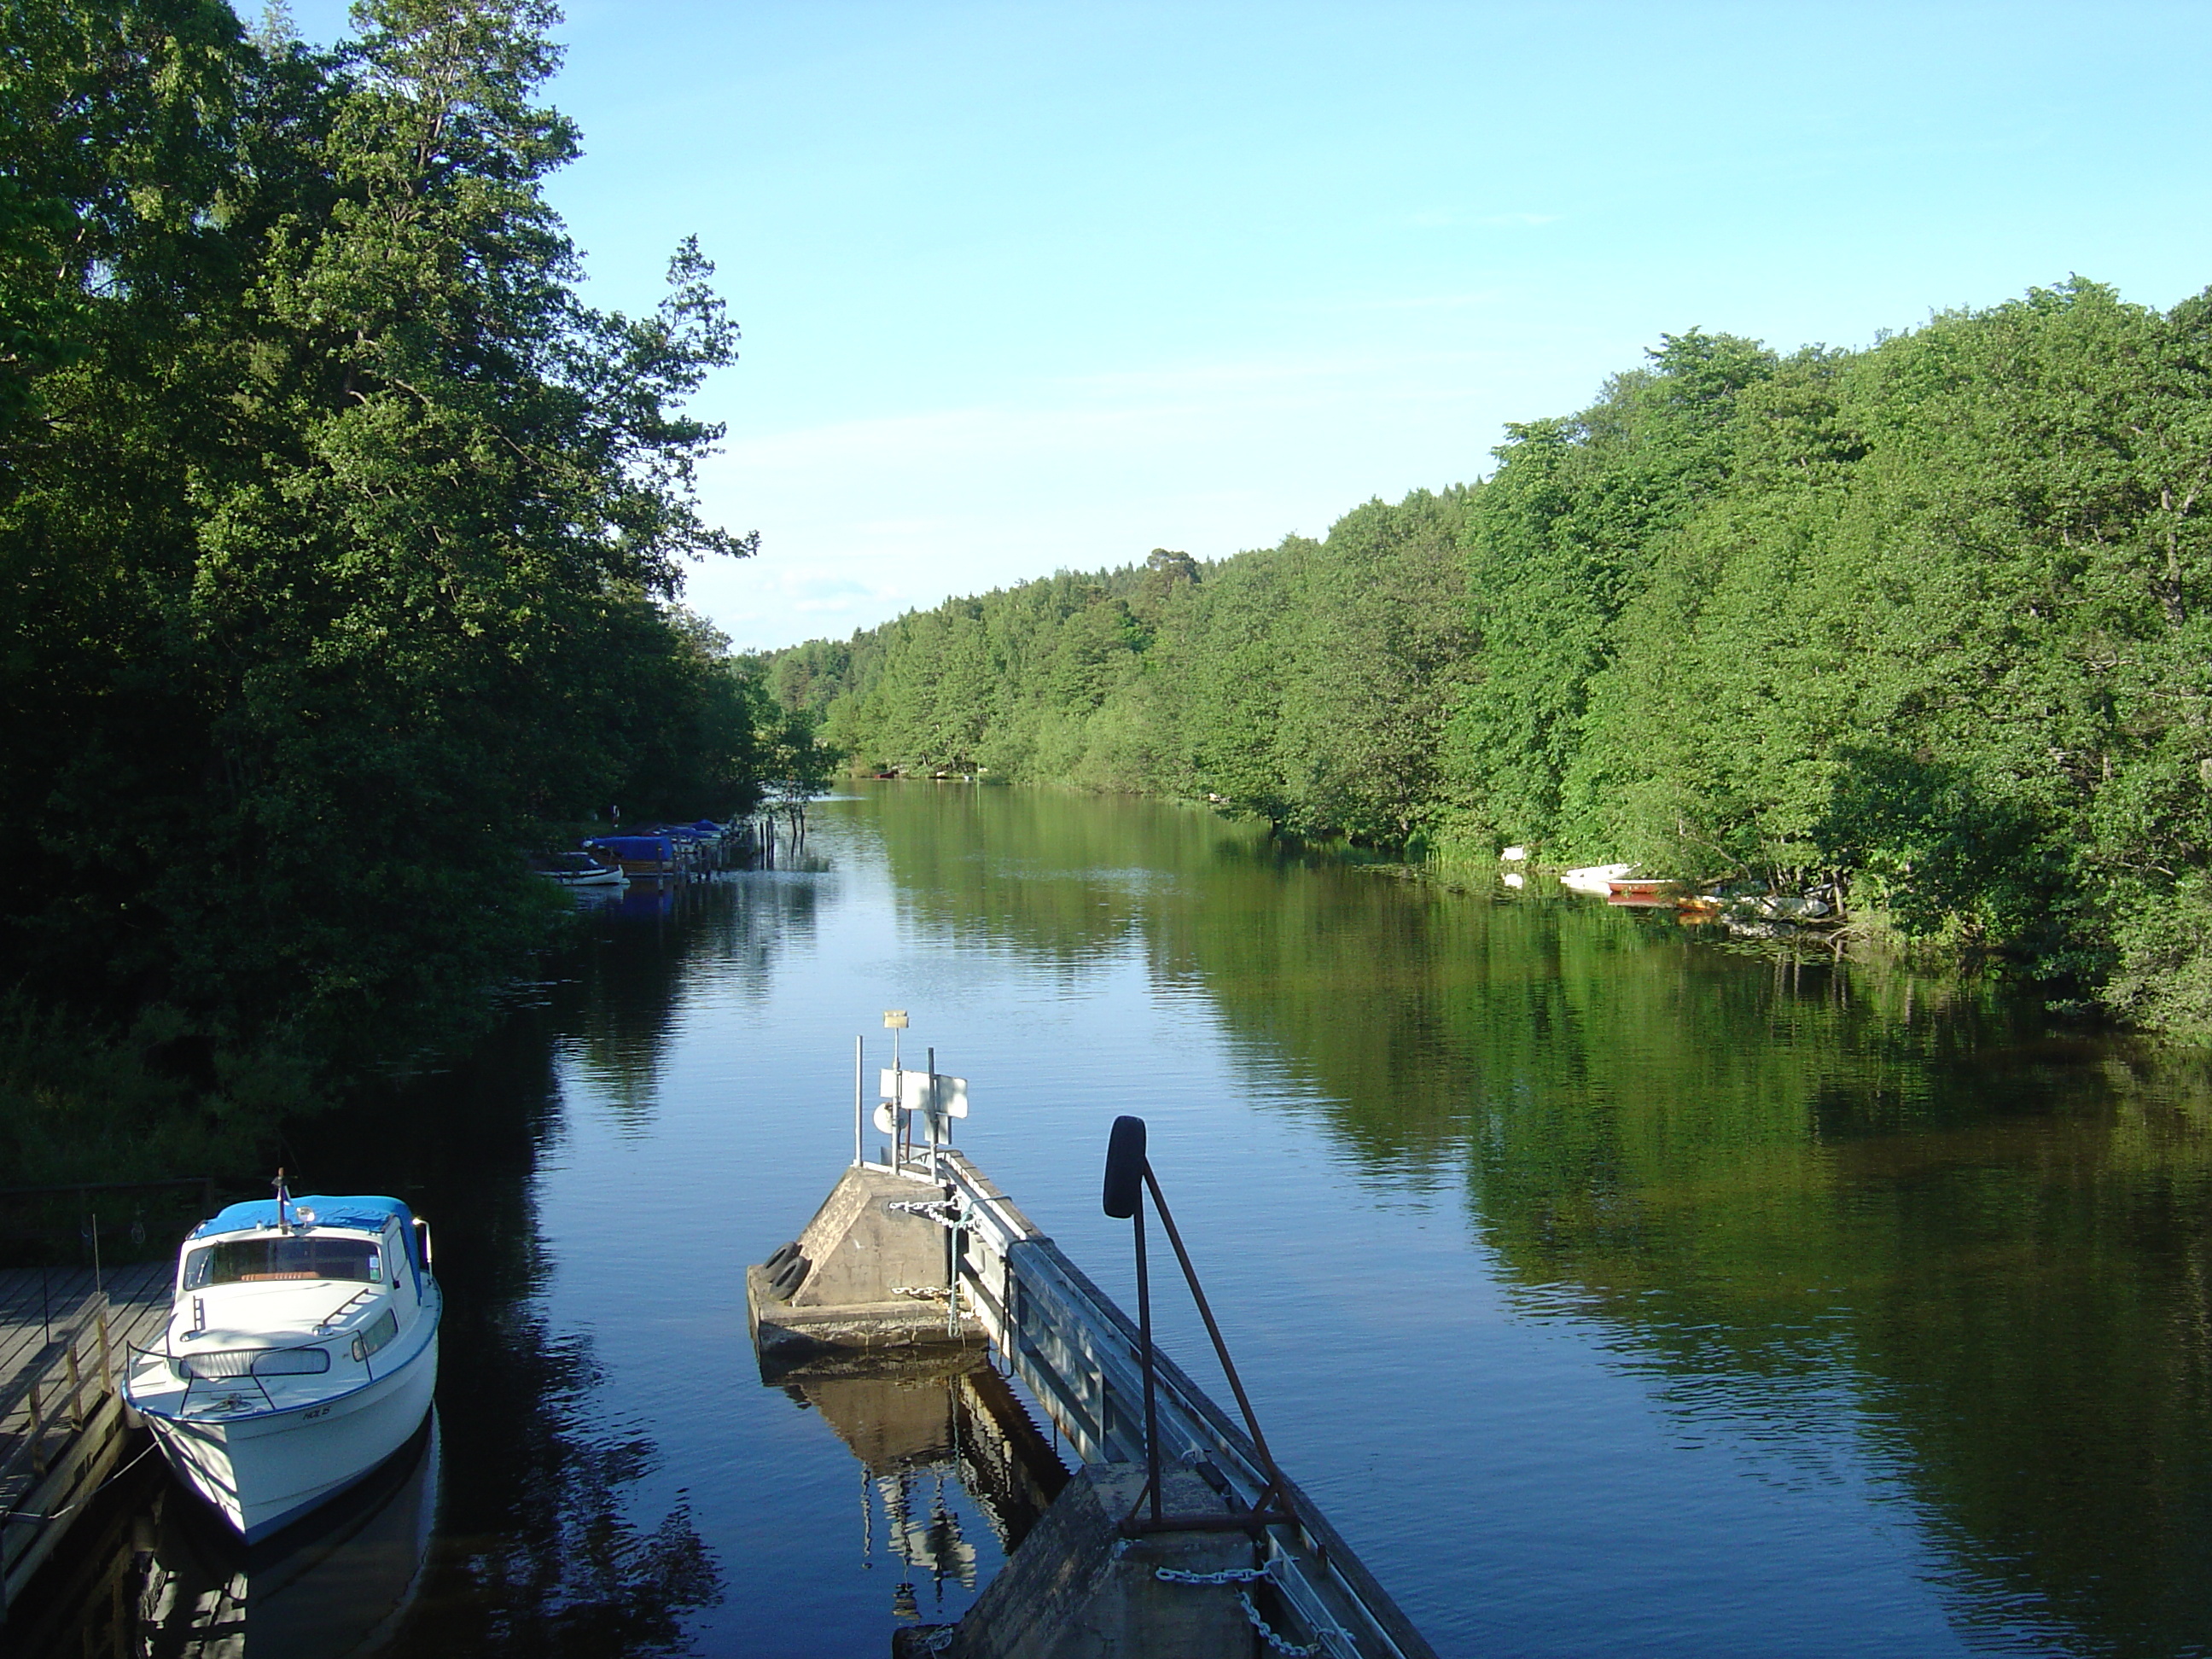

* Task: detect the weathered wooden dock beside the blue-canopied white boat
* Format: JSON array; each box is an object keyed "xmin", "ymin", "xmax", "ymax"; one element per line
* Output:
[{"xmin": 0, "ymin": 1260, "xmax": 175, "ymax": 1619}]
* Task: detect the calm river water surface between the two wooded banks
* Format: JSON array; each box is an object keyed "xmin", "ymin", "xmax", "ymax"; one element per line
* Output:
[{"xmin": 30, "ymin": 783, "xmax": 2212, "ymax": 1656}]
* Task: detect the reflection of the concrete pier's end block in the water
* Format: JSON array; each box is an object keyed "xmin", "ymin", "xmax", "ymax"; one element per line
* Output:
[{"xmin": 767, "ymin": 1352, "xmax": 1068, "ymax": 1621}]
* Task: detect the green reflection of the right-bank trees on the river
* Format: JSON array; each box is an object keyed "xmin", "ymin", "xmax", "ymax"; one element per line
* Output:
[{"xmin": 853, "ymin": 792, "xmax": 2212, "ymax": 1655}]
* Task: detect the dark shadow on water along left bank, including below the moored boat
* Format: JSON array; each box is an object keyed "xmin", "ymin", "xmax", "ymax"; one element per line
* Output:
[{"xmin": 11, "ymin": 882, "xmax": 812, "ymax": 1659}]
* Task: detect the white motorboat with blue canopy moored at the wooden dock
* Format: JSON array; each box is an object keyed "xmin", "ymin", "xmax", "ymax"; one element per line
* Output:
[{"xmin": 124, "ymin": 1181, "xmax": 442, "ymax": 1544}]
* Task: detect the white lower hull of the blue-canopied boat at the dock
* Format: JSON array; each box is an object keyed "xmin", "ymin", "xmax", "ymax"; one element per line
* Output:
[{"xmin": 146, "ymin": 1331, "xmax": 438, "ymax": 1544}]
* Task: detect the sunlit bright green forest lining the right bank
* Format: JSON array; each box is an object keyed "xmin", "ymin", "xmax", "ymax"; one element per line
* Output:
[{"xmin": 783, "ymin": 279, "xmax": 2212, "ymax": 1042}]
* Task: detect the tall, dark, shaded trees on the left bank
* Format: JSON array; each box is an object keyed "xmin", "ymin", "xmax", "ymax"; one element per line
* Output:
[{"xmin": 0, "ymin": 0, "xmax": 792, "ymax": 1185}]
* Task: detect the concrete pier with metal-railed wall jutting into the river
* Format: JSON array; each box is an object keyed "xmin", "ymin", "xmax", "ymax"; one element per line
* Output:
[{"xmin": 748, "ymin": 1148, "xmax": 1434, "ymax": 1659}]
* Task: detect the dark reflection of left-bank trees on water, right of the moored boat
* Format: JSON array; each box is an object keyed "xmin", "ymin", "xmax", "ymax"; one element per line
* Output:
[{"xmin": 236, "ymin": 881, "xmax": 752, "ymax": 1659}]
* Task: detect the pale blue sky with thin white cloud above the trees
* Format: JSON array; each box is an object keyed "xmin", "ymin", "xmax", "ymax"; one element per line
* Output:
[{"xmin": 285, "ymin": 0, "xmax": 2212, "ymax": 648}]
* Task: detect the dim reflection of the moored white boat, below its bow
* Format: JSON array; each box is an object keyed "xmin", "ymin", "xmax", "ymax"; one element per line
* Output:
[{"xmin": 135, "ymin": 1412, "xmax": 438, "ymax": 1659}]
